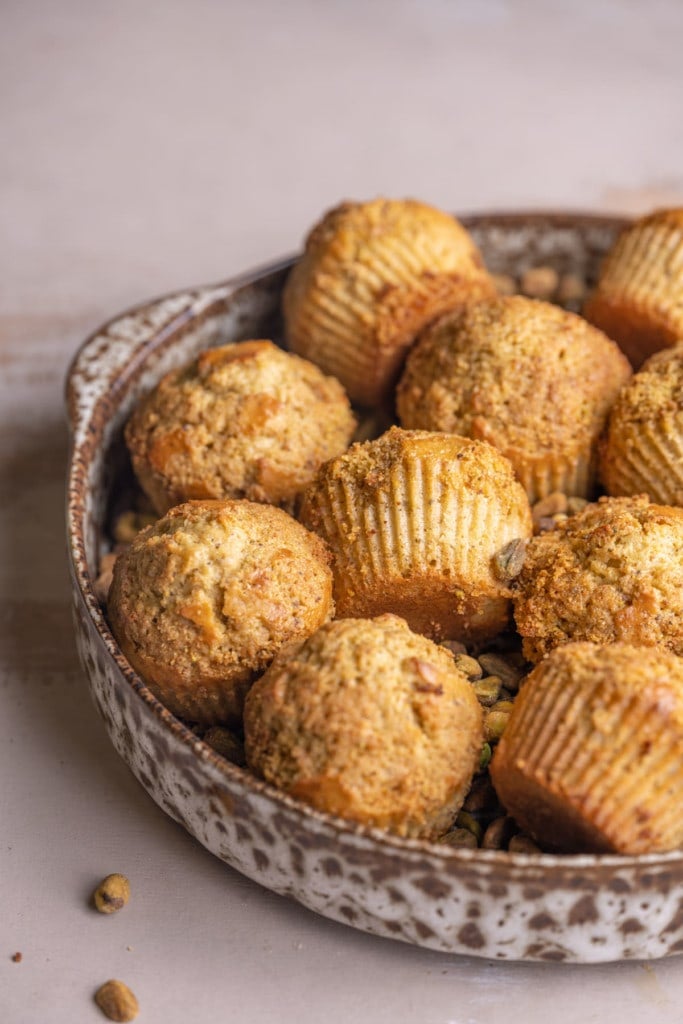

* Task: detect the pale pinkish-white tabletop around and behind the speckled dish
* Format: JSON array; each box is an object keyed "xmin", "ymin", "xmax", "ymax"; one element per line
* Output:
[{"xmin": 0, "ymin": 0, "xmax": 683, "ymax": 1024}]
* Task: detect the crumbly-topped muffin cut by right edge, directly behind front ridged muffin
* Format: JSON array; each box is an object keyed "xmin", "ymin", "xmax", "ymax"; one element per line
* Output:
[{"xmin": 514, "ymin": 495, "xmax": 683, "ymax": 662}]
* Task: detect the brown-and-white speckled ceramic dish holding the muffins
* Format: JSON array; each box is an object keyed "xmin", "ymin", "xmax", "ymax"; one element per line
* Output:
[{"xmin": 68, "ymin": 214, "xmax": 683, "ymax": 963}]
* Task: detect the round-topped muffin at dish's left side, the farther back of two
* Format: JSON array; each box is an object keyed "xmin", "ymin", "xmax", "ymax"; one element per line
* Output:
[{"xmin": 126, "ymin": 341, "xmax": 355, "ymax": 515}]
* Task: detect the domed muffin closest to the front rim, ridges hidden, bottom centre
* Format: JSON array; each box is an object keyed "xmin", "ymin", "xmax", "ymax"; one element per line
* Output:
[{"xmin": 245, "ymin": 615, "xmax": 483, "ymax": 837}]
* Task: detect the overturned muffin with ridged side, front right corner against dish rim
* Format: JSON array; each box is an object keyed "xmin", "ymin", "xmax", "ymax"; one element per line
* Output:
[{"xmin": 490, "ymin": 643, "xmax": 683, "ymax": 854}]
